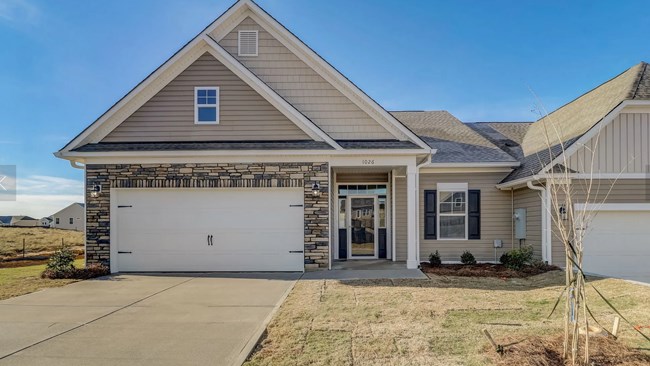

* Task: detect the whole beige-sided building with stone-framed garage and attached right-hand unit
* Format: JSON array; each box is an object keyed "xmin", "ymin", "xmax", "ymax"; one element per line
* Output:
[{"xmin": 55, "ymin": 0, "xmax": 650, "ymax": 276}]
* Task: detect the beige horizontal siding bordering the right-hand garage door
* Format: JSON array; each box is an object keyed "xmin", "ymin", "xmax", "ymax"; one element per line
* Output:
[{"xmin": 551, "ymin": 179, "xmax": 650, "ymax": 267}]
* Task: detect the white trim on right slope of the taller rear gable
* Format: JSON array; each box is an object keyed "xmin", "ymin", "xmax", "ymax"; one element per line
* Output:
[{"xmin": 205, "ymin": 0, "xmax": 428, "ymax": 148}]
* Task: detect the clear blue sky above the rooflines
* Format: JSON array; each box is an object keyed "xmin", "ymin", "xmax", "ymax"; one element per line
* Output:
[{"xmin": 0, "ymin": 0, "xmax": 650, "ymax": 216}]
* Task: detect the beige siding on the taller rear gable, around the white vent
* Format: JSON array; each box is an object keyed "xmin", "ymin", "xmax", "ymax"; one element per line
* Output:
[{"xmin": 219, "ymin": 17, "xmax": 395, "ymax": 140}]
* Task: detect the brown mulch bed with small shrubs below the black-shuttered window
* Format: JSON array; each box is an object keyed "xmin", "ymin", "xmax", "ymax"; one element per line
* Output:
[{"xmin": 421, "ymin": 263, "xmax": 559, "ymax": 278}]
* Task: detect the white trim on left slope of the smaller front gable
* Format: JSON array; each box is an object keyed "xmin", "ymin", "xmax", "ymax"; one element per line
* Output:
[{"xmin": 60, "ymin": 37, "xmax": 201, "ymax": 155}]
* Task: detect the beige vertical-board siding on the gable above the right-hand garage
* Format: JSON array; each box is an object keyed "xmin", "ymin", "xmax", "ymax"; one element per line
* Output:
[{"xmin": 569, "ymin": 113, "xmax": 650, "ymax": 173}]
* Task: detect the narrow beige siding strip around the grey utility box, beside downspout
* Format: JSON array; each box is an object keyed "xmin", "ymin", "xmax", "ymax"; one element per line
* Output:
[{"xmin": 508, "ymin": 188, "xmax": 542, "ymax": 260}]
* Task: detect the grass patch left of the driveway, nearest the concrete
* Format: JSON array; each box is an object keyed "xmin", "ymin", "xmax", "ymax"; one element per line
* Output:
[{"xmin": 0, "ymin": 259, "xmax": 84, "ymax": 300}]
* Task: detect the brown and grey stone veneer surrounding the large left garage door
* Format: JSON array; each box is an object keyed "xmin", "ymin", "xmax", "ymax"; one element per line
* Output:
[{"xmin": 86, "ymin": 163, "xmax": 329, "ymax": 270}]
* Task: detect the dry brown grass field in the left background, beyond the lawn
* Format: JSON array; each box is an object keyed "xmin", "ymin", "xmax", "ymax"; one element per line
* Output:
[{"xmin": 0, "ymin": 227, "xmax": 84, "ymax": 260}]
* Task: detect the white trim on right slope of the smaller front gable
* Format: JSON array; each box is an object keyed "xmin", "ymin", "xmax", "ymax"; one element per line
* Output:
[{"xmin": 201, "ymin": 34, "xmax": 343, "ymax": 150}]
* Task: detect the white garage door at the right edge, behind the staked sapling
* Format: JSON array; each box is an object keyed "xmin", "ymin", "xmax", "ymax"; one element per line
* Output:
[{"xmin": 583, "ymin": 205, "xmax": 650, "ymax": 282}]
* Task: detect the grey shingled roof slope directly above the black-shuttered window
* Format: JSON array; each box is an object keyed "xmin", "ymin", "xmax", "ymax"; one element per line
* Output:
[{"xmin": 391, "ymin": 111, "xmax": 517, "ymax": 165}]
